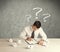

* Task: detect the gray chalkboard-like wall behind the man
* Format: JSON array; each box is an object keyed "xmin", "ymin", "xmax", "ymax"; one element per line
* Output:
[{"xmin": 0, "ymin": 0, "xmax": 60, "ymax": 38}]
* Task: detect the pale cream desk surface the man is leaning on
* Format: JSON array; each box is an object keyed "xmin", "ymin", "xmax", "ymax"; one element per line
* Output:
[{"xmin": 0, "ymin": 39, "xmax": 60, "ymax": 52}]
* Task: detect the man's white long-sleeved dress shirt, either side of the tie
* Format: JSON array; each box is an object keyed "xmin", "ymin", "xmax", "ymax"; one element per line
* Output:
[{"xmin": 20, "ymin": 26, "xmax": 47, "ymax": 41}]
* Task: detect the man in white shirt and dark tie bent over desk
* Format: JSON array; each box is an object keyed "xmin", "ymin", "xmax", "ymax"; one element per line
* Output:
[{"xmin": 20, "ymin": 21, "xmax": 47, "ymax": 45}]
